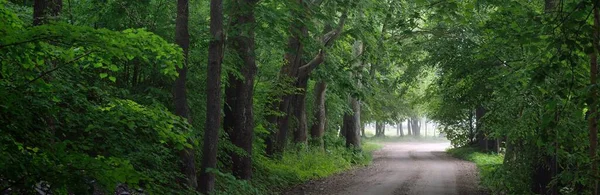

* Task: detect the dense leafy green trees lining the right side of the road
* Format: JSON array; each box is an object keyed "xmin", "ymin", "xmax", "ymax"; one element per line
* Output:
[{"xmin": 424, "ymin": 0, "xmax": 599, "ymax": 194}]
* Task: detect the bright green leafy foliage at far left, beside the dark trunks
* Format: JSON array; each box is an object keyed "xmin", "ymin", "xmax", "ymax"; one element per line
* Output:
[{"xmin": 0, "ymin": 1, "xmax": 194, "ymax": 194}]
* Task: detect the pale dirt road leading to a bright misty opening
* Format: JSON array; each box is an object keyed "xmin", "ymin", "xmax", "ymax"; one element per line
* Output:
[{"xmin": 283, "ymin": 142, "xmax": 484, "ymax": 195}]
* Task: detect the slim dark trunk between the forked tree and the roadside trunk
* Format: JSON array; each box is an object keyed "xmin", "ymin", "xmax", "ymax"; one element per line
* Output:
[{"xmin": 310, "ymin": 81, "xmax": 327, "ymax": 147}]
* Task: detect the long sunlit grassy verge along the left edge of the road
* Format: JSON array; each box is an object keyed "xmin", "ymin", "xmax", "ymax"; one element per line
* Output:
[{"xmin": 217, "ymin": 142, "xmax": 383, "ymax": 194}]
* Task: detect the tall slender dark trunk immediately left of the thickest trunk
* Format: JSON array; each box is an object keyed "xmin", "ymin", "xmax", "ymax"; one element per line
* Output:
[{"xmin": 198, "ymin": 0, "xmax": 225, "ymax": 194}]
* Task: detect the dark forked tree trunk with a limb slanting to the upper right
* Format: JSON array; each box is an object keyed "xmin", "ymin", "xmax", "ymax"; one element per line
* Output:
[{"xmin": 267, "ymin": 3, "xmax": 348, "ymax": 155}]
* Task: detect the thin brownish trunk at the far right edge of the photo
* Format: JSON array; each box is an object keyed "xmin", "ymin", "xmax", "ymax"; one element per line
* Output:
[{"xmin": 588, "ymin": 1, "xmax": 600, "ymax": 194}]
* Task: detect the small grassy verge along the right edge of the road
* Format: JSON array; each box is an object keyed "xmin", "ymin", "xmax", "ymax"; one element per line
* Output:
[{"xmin": 448, "ymin": 147, "xmax": 504, "ymax": 192}]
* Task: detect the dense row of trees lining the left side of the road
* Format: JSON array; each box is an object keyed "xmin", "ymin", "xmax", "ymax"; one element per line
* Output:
[{"xmin": 0, "ymin": 0, "xmax": 435, "ymax": 194}]
